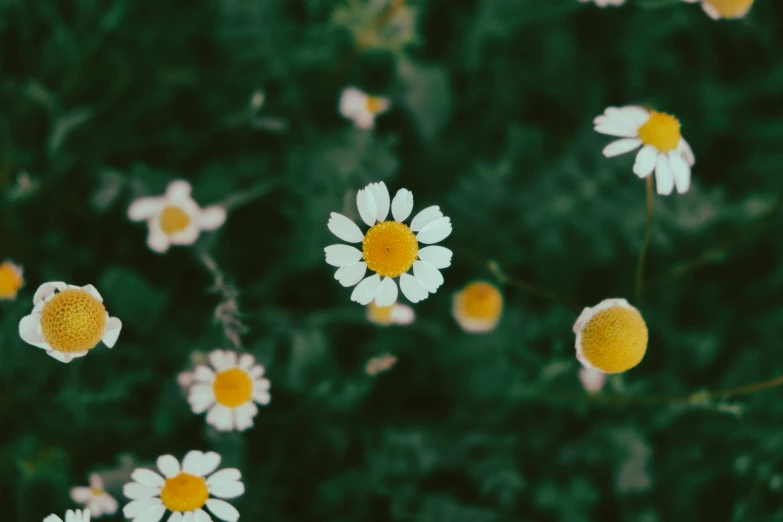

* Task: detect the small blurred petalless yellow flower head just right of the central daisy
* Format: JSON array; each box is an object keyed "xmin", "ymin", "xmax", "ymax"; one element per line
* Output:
[{"xmin": 451, "ymin": 281, "xmax": 503, "ymax": 333}]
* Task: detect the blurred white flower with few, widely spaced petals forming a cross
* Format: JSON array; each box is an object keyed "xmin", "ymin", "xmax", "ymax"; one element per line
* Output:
[{"xmin": 128, "ymin": 180, "xmax": 226, "ymax": 254}]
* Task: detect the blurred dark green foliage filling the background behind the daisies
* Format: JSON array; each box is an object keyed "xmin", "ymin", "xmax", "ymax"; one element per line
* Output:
[{"xmin": 0, "ymin": 0, "xmax": 783, "ymax": 522}]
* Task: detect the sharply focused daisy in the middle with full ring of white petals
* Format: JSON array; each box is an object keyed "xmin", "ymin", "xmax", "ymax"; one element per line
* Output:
[{"xmin": 324, "ymin": 182, "xmax": 452, "ymax": 306}]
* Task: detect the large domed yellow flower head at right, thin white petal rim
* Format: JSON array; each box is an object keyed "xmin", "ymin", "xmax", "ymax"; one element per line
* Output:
[{"xmin": 574, "ymin": 299, "xmax": 648, "ymax": 373}]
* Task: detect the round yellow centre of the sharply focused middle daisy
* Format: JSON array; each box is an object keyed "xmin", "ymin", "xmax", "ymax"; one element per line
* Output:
[{"xmin": 362, "ymin": 221, "xmax": 419, "ymax": 277}]
